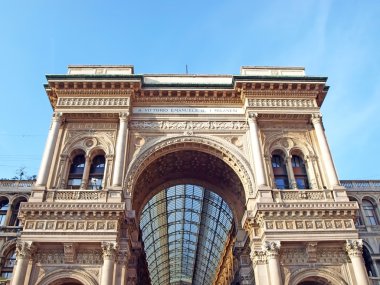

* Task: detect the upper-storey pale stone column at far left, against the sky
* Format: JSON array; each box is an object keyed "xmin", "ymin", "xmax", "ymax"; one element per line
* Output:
[{"xmin": 36, "ymin": 112, "xmax": 62, "ymax": 186}]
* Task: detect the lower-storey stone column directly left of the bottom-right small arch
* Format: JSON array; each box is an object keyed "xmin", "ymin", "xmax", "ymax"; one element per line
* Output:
[{"xmin": 263, "ymin": 241, "xmax": 282, "ymax": 285}]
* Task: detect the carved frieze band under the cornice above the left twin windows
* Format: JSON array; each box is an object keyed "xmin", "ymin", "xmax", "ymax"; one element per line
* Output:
[{"xmin": 56, "ymin": 97, "xmax": 129, "ymax": 108}]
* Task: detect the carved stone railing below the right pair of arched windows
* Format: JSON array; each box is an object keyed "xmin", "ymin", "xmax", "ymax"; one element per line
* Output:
[{"xmin": 273, "ymin": 190, "xmax": 334, "ymax": 202}]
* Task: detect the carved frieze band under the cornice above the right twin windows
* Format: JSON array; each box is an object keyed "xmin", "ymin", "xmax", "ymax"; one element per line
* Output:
[{"xmin": 248, "ymin": 98, "xmax": 318, "ymax": 108}]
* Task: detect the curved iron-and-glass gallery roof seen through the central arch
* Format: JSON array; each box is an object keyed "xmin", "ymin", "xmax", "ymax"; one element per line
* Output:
[{"xmin": 140, "ymin": 184, "xmax": 233, "ymax": 285}]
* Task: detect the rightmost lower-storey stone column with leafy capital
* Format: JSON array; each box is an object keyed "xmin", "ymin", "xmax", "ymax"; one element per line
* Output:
[{"xmin": 346, "ymin": 239, "xmax": 370, "ymax": 285}]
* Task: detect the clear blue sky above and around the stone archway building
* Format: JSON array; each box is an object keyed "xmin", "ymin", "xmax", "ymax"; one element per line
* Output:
[{"xmin": 0, "ymin": 0, "xmax": 380, "ymax": 179}]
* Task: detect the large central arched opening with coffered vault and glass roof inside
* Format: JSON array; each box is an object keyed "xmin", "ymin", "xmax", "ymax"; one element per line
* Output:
[{"xmin": 127, "ymin": 137, "xmax": 252, "ymax": 284}]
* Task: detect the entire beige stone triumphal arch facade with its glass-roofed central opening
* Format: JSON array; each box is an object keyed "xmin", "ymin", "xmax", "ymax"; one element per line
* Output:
[{"xmin": 12, "ymin": 66, "xmax": 369, "ymax": 285}]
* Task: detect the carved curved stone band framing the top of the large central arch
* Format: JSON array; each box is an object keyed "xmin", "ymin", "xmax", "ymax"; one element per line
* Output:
[{"xmin": 123, "ymin": 135, "xmax": 254, "ymax": 197}]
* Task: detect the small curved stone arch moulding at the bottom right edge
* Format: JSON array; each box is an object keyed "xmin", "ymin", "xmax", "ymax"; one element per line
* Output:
[{"xmin": 285, "ymin": 268, "xmax": 348, "ymax": 285}]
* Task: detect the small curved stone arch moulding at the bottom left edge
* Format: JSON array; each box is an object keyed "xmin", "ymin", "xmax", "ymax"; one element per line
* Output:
[{"xmin": 36, "ymin": 268, "xmax": 98, "ymax": 285}]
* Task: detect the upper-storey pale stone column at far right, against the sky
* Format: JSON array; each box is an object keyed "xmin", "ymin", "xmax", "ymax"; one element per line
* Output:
[{"xmin": 311, "ymin": 114, "xmax": 339, "ymax": 187}]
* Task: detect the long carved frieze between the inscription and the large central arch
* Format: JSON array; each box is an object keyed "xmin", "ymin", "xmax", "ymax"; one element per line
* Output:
[{"xmin": 129, "ymin": 121, "xmax": 248, "ymax": 131}]
